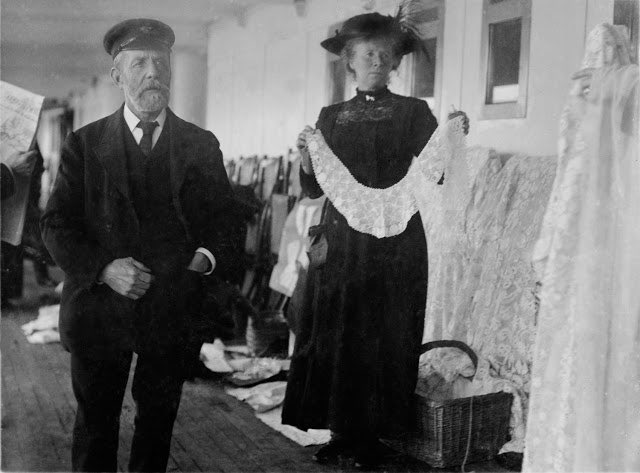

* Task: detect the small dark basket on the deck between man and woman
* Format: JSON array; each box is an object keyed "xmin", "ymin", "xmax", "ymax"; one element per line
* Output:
[{"xmin": 246, "ymin": 310, "xmax": 289, "ymax": 356}]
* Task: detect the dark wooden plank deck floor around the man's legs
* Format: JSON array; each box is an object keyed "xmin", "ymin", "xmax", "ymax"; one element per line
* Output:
[{"xmin": 0, "ymin": 260, "xmax": 506, "ymax": 472}]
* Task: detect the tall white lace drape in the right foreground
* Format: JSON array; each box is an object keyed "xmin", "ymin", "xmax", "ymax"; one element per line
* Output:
[{"xmin": 523, "ymin": 25, "xmax": 640, "ymax": 471}]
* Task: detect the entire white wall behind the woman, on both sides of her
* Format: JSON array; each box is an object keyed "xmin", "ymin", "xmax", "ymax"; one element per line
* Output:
[{"xmin": 205, "ymin": 0, "xmax": 613, "ymax": 158}]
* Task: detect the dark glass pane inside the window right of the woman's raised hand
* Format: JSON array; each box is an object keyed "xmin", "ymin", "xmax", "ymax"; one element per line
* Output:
[{"xmin": 486, "ymin": 18, "xmax": 522, "ymax": 103}]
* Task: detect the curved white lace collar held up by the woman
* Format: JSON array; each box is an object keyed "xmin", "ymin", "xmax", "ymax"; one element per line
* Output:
[{"xmin": 308, "ymin": 117, "xmax": 464, "ymax": 238}]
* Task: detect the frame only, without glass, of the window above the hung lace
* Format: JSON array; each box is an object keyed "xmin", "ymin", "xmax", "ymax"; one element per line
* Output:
[{"xmin": 478, "ymin": 0, "xmax": 531, "ymax": 120}]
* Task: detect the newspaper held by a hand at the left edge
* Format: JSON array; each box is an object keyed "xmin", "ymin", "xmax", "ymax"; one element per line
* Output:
[{"xmin": 0, "ymin": 81, "xmax": 44, "ymax": 246}]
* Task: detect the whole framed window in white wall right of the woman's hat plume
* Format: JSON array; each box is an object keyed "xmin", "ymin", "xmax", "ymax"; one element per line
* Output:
[{"xmin": 480, "ymin": 0, "xmax": 531, "ymax": 120}]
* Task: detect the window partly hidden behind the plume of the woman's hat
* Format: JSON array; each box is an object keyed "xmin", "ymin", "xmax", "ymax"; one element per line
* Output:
[{"xmin": 405, "ymin": 0, "xmax": 444, "ymax": 116}]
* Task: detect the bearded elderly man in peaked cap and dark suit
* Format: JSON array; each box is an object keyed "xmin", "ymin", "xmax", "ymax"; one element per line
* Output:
[{"xmin": 41, "ymin": 19, "xmax": 235, "ymax": 471}]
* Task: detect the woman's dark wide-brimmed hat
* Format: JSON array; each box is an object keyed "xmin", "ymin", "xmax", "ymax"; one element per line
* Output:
[{"xmin": 320, "ymin": 12, "xmax": 420, "ymax": 56}]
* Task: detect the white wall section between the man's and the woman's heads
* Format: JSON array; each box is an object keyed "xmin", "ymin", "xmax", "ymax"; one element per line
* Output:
[{"xmin": 206, "ymin": 0, "xmax": 408, "ymax": 158}]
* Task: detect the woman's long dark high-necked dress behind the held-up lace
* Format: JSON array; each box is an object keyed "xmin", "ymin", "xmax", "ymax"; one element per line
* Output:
[{"xmin": 282, "ymin": 89, "xmax": 437, "ymax": 436}]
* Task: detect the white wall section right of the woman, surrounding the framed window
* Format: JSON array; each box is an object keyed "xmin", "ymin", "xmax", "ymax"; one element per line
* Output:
[{"xmin": 450, "ymin": 0, "xmax": 613, "ymax": 155}]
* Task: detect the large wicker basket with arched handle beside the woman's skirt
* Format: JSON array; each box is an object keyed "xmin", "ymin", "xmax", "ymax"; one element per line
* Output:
[{"xmin": 389, "ymin": 340, "xmax": 513, "ymax": 468}]
